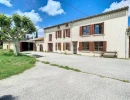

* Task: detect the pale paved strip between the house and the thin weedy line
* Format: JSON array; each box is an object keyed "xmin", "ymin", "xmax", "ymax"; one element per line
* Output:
[{"xmin": 22, "ymin": 52, "xmax": 130, "ymax": 81}]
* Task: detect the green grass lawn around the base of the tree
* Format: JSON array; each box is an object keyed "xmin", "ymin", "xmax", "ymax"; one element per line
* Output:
[{"xmin": 0, "ymin": 50, "xmax": 36, "ymax": 79}]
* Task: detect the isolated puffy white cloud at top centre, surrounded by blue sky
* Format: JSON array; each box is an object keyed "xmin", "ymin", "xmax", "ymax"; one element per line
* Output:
[{"xmin": 39, "ymin": 0, "xmax": 65, "ymax": 16}]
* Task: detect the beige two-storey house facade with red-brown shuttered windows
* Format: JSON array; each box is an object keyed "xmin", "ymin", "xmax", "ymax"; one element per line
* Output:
[{"xmin": 43, "ymin": 7, "xmax": 129, "ymax": 58}]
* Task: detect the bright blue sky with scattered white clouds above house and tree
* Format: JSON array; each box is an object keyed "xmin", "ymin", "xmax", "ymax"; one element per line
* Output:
[{"xmin": 0, "ymin": 0, "xmax": 130, "ymax": 37}]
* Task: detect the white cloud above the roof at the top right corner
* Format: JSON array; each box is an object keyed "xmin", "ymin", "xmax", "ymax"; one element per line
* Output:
[{"xmin": 103, "ymin": 0, "xmax": 130, "ymax": 16}]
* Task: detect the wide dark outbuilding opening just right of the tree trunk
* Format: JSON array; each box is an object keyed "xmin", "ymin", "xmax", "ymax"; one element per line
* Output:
[{"xmin": 21, "ymin": 42, "xmax": 34, "ymax": 51}]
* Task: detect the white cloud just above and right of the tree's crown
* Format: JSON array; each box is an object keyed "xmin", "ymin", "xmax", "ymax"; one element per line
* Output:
[{"xmin": 15, "ymin": 10, "xmax": 42, "ymax": 24}]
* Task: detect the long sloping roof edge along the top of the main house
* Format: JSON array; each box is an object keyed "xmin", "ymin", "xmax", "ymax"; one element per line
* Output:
[{"xmin": 44, "ymin": 6, "xmax": 129, "ymax": 29}]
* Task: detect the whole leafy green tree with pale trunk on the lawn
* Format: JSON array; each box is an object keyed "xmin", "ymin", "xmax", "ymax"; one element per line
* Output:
[{"xmin": 0, "ymin": 14, "xmax": 37, "ymax": 55}]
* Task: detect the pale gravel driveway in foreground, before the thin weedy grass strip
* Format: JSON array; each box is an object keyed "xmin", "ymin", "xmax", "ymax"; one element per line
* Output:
[{"xmin": 0, "ymin": 62, "xmax": 130, "ymax": 100}]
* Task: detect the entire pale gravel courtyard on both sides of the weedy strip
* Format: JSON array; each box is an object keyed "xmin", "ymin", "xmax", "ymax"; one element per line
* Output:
[{"xmin": 0, "ymin": 52, "xmax": 130, "ymax": 100}]
